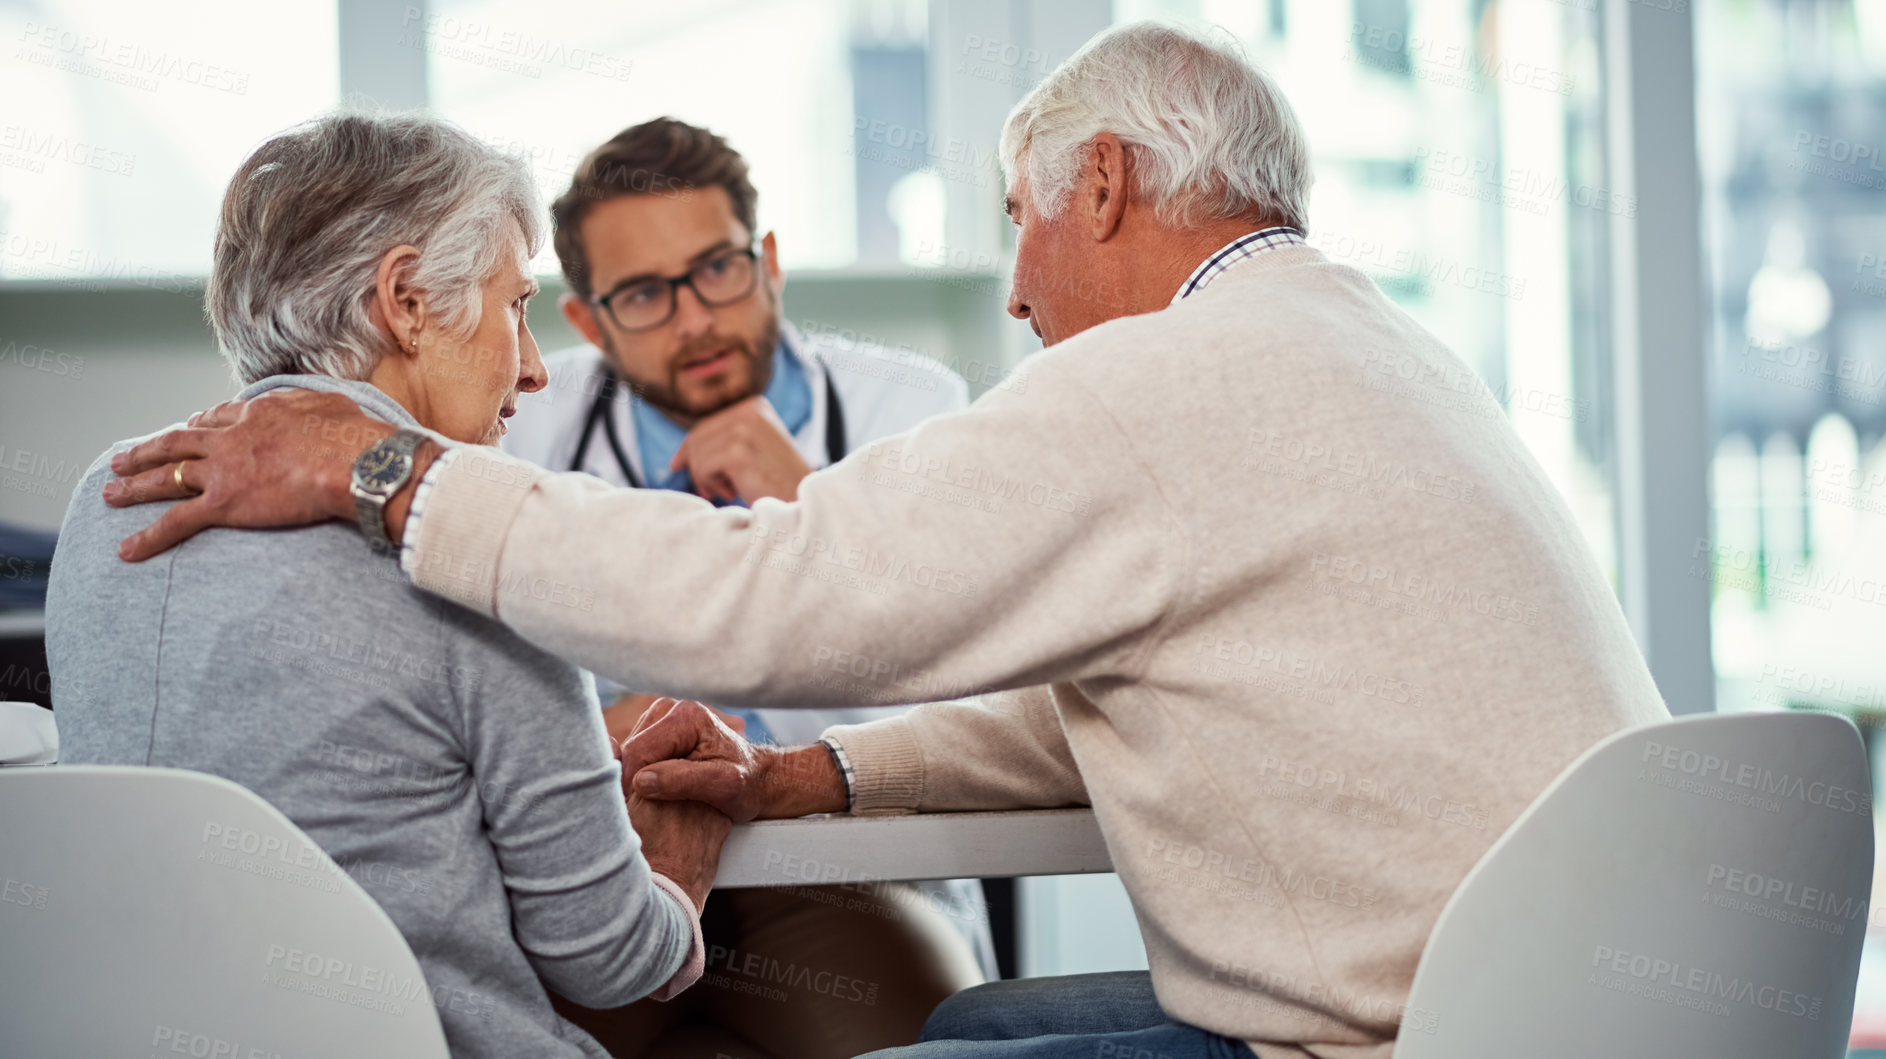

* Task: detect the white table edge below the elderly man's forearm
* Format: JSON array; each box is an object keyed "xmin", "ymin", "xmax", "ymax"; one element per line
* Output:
[{"xmin": 715, "ymin": 808, "xmax": 1113, "ymax": 889}]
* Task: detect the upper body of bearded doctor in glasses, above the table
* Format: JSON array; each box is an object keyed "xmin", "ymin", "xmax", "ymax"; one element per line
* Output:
[{"xmin": 504, "ymin": 117, "xmax": 969, "ymax": 742}]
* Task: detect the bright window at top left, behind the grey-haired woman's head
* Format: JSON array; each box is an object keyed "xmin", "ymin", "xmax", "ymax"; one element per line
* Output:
[{"xmin": 0, "ymin": 0, "xmax": 339, "ymax": 290}]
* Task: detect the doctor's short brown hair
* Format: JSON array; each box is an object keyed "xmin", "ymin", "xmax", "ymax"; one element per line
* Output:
[{"xmin": 551, "ymin": 117, "xmax": 760, "ymax": 298}]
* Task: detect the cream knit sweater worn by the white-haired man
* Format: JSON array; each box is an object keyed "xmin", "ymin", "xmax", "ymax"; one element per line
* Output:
[{"xmin": 411, "ymin": 247, "xmax": 1667, "ymax": 1059}]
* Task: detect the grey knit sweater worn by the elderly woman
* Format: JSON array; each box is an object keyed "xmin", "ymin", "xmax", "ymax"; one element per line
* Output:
[{"xmin": 45, "ymin": 375, "xmax": 692, "ymax": 1057}]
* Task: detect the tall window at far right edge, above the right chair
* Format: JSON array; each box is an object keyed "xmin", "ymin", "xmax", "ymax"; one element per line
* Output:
[{"xmin": 1692, "ymin": 0, "xmax": 1886, "ymax": 1048}]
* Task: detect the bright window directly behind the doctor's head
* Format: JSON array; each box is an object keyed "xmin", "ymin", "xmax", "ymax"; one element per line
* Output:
[{"xmin": 424, "ymin": 0, "xmax": 928, "ymax": 271}]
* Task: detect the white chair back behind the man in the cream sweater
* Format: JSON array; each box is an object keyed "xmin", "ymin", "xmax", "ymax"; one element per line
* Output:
[{"xmin": 1396, "ymin": 712, "xmax": 1873, "ymax": 1059}]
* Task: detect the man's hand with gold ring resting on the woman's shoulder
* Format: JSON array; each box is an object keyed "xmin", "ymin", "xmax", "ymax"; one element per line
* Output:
[{"xmin": 104, "ymin": 390, "xmax": 438, "ymax": 562}]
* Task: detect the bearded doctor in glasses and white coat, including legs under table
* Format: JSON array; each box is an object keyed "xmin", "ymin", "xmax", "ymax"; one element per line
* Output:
[{"xmin": 482, "ymin": 117, "xmax": 994, "ymax": 1057}]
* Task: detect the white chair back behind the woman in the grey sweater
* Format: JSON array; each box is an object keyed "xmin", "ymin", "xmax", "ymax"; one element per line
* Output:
[{"xmin": 0, "ymin": 765, "xmax": 447, "ymax": 1059}]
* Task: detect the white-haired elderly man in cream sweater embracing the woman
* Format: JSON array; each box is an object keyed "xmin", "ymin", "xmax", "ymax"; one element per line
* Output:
[{"xmin": 111, "ymin": 24, "xmax": 1667, "ymax": 1059}]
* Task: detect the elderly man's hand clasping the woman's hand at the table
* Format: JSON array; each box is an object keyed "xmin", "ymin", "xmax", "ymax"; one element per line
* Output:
[{"xmin": 622, "ymin": 699, "xmax": 845, "ymax": 823}]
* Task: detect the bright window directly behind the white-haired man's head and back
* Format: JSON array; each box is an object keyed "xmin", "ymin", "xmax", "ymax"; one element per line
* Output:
[{"xmin": 1115, "ymin": 0, "xmax": 1633, "ymax": 569}]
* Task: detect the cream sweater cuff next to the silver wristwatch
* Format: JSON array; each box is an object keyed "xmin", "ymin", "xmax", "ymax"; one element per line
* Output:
[{"xmin": 407, "ymin": 445, "xmax": 543, "ymax": 618}]
